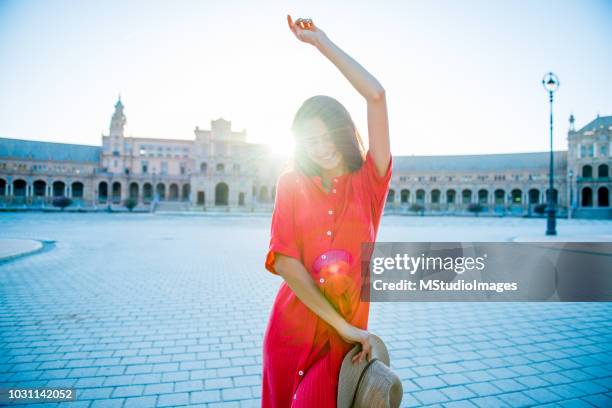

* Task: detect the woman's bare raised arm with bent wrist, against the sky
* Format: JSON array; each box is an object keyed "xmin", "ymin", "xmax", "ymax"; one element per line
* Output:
[{"xmin": 287, "ymin": 15, "xmax": 391, "ymax": 177}]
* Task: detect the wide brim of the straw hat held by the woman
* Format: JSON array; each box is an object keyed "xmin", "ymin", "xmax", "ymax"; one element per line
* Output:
[{"xmin": 337, "ymin": 333, "xmax": 390, "ymax": 408}]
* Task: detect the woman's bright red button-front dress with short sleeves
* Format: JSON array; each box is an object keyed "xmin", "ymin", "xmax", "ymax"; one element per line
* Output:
[{"xmin": 261, "ymin": 150, "xmax": 393, "ymax": 408}]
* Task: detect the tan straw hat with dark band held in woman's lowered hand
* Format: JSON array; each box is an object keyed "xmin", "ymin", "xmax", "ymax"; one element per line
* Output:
[{"xmin": 337, "ymin": 333, "xmax": 403, "ymax": 408}]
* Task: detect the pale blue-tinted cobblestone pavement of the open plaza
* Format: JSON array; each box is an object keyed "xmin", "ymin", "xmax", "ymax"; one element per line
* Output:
[{"xmin": 0, "ymin": 213, "xmax": 612, "ymax": 408}]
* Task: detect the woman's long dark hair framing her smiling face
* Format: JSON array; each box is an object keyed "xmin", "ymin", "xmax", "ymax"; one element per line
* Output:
[{"xmin": 291, "ymin": 95, "xmax": 365, "ymax": 176}]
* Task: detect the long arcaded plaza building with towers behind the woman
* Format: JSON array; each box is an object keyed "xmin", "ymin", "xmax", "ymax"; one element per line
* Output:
[{"xmin": 0, "ymin": 100, "xmax": 612, "ymax": 218}]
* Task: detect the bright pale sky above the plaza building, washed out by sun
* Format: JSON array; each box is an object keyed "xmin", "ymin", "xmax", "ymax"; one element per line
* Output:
[{"xmin": 0, "ymin": 0, "xmax": 612, "ymax": 155}]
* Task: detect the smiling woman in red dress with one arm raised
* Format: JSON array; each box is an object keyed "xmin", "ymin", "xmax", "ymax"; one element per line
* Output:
[{"xmin": 262, "ymin": 16, "xmax": 392, "ymax": 408}]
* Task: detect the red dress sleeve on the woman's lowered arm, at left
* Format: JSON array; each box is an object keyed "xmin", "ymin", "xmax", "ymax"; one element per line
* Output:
[{"xmin": 265, "ymin": 173, "xmax": 301, "ymax": 275}]
